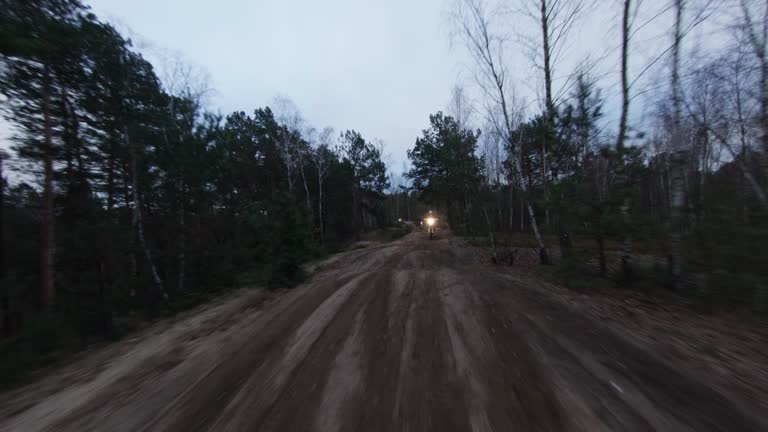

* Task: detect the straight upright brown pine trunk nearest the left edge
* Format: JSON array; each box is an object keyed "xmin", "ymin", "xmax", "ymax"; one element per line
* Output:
[{"xmin": 40, "ymin": 68, "xmax": 56, "ymax": 310}]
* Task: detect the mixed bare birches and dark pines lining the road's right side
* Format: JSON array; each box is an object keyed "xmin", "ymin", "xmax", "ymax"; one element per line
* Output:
[{"xmin": 408, "ymin": 0, "xmax": 768, "ymax": 312}]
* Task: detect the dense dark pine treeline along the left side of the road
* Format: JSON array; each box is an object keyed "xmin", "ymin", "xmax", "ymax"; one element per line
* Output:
[{"xmin": 0, "ymin": 0, "xmax": 391, "ymax": 352}]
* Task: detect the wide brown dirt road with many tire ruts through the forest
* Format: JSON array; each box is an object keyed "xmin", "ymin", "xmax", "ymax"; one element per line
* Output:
[{"xmin": 0, "ymin": 233, "xmax": 768, "ymax": 432}]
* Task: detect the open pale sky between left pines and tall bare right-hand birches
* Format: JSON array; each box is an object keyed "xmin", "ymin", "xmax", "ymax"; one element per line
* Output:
[{"xmin": 89, "ymin": 0, "xmax": 472, "ymax": 171}]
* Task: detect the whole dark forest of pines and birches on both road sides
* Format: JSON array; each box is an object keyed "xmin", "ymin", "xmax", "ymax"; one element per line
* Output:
[{"xmin": 0, "ymin": 0, "xmax": 768, "ymax": 384}]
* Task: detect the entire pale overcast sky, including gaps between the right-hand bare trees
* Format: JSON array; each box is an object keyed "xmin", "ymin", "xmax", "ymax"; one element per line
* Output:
[{"xmin": 0, "ymin": 0, "xmax": 728, "ymax": 176}]
